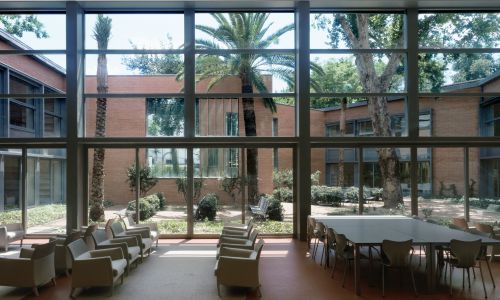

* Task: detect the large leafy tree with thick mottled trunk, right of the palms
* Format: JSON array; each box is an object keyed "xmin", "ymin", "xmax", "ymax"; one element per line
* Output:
[{"xmin": 316, "ymin": 13, "xmax": 500, "ymax": 208}]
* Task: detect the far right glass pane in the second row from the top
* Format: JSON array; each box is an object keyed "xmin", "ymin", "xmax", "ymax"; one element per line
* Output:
[{"xmin": 418, "ymin": 53, "xmax": 500, "ymax": 93}]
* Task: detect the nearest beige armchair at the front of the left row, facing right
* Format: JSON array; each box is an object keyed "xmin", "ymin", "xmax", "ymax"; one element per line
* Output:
[{"xmin": 68, "ymin": 239, "xmax": 127, "ymax": 297}]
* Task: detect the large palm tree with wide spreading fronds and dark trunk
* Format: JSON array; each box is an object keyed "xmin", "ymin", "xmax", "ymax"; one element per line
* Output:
[{"xmin": 191, "ymin": 13, "xmax": 322, "ymax": 202}]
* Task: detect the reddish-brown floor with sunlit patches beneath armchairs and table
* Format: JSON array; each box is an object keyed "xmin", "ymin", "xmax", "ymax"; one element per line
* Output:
[{"xmin": 0, "ymin": 239, "xmax": 500, "ymax": 300}]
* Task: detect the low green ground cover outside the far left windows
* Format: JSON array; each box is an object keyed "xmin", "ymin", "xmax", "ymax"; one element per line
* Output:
[{"xmin": 0, "ymin": 204, "xmax": 66, "ymax": 227}]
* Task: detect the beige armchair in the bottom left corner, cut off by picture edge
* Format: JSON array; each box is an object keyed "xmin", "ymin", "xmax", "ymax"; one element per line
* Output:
[{"xmin": 0, "ymin": 242, "xmax": 56, "ymax": 296}]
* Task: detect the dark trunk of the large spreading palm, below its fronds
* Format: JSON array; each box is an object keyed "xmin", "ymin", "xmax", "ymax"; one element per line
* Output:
[{"xmin": 240, "ymin": 75, "xmax": 259, "ymax": 204}]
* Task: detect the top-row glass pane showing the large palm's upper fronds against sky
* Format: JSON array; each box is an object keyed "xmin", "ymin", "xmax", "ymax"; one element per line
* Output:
[{"xmin": 195, "ymin": 12, "xmax": 295, "ymax": 49}]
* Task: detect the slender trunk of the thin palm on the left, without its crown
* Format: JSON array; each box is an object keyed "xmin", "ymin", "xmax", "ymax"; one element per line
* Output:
[{"xmin": 89, "ymin": 23, "xmax": 109, "ymax": 221}]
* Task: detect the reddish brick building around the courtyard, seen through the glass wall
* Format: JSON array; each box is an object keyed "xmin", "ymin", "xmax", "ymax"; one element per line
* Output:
[{"xmin": 0, "ymin": 31, "xmax": 500, "ymax": 210}]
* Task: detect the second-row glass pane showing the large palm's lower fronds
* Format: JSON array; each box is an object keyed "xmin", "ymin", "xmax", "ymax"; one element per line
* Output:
[{"xmin": 195, "ymin": 53, "xmax": 295, "ymax": 93}]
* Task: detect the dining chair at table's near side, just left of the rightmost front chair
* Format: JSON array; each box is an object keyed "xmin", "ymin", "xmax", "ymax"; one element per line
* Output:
[{"xmin": 380, "ymin": 240, "xmax": 418, "ymax": 297}]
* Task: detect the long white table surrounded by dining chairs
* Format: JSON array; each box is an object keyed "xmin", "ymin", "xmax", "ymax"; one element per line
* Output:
[{"xmin": 315, "ymin": 215, "xmax": 500, "ymax": 295}]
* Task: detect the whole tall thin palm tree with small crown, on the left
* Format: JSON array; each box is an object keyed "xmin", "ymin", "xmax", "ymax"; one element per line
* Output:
[{"xmin": 89, "ymin": 14, "xmax": 111, "ymax": 221}]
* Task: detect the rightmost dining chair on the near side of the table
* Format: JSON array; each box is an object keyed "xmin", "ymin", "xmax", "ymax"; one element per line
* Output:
[{"xmin": 445, "ymin": 239, "xmax": 488, "ymax": 298}]
